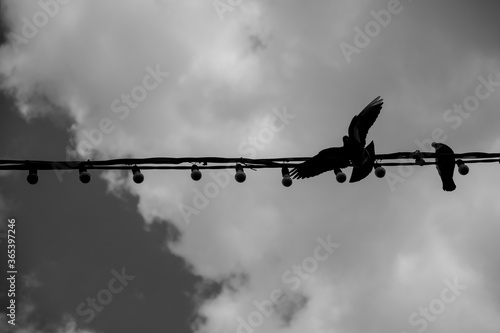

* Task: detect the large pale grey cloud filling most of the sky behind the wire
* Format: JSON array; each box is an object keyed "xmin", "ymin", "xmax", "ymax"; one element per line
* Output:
[{"xmin": 0, "ymin": 0, "xmax": 500, "ymax": 332}]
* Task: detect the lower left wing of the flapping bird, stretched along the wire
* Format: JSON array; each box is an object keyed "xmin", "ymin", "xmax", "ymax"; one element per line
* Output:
[{"xmin": 290, "ymin": 147, "xmax": 349, "ymax": 179}]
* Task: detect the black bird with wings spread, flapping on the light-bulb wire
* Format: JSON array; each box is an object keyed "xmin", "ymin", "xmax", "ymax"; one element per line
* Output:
[{"xmin": 290, "ymin": 96, "xmax": 383, "ymax": 183}]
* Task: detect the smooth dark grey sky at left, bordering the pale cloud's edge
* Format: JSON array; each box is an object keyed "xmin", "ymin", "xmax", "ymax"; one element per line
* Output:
[{"xmin": 0, "ymin": 91, "xmax": 200, "ymax": 332}]
